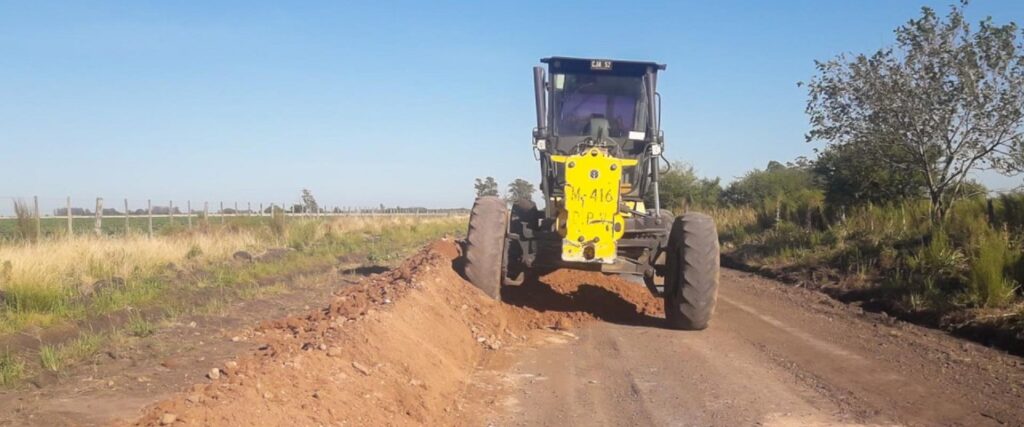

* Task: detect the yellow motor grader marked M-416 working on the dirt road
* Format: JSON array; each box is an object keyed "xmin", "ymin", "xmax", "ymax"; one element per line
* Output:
[{"xmin": 463, "ymin": 56, "xmax": 719, "ymax": 330}]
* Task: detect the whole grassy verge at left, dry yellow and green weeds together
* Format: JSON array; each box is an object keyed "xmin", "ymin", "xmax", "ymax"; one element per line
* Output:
[{"xmin": 0, "ymin": 215, "xmax": 465, "ymax": 386}]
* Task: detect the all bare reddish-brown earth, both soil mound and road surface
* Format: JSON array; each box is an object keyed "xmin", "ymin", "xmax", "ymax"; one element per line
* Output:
[{"xmin": 0, "ymin": 237, "xmax": 1024, "ymax": 426}]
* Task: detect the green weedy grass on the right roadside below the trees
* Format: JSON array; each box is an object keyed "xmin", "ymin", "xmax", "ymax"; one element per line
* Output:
[{"xmin": 711, "ymin": 195, "xmax": 1024, "ymax": 311}]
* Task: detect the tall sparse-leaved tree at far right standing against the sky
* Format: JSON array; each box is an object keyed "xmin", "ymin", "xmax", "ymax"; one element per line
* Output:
[{"xmin": 807, "ymin": 1, "xmax": 1024, "ymax": 221}]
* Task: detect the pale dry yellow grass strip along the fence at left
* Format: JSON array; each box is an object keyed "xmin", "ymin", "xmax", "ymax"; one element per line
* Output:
[{"xmin": 0, "ymin": 212, "xmax": 464, "ymax": 334}]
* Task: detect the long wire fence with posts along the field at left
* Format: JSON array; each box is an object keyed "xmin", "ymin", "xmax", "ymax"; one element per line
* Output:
[{"xmin": 0, "ymin": 196, "xmax": 469, "ymax": 239}]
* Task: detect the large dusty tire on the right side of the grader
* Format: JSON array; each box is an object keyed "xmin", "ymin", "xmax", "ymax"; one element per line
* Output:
[{"xmin": 665, "ymin": 212, "xmax": 719, "ymax": 331}]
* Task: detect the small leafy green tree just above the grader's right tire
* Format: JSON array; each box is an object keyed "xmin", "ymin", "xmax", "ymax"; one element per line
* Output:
[{"xmin": 645, "ymin": 163, "xmax": 722, "ymax": 212}]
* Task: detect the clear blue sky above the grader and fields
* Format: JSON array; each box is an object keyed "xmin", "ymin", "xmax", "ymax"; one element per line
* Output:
[{"xmin": 0, "ymin": 0, "xmax": 1024, "ymax": 209}]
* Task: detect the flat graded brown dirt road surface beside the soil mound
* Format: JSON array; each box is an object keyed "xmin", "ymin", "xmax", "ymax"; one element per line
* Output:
[{"xmin": 489, "ymin": 269, "xmax": 1024, "ymax": 426}]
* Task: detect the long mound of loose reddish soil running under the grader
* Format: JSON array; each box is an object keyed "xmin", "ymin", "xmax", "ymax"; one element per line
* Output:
[{"xmin": 135, "ymin": 237, "xmax": 660, "ymax": 425}]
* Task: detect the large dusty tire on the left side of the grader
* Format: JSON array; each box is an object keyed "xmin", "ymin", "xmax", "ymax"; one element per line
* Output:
[{"xmin": 464, "ymin": 196, "xmax": 508, "ymax": 301}]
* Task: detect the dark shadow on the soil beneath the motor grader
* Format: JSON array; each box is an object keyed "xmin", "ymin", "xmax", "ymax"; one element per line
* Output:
[{"xmin": 502, "ymin": 276, "xmax": 666, "ymax": 328}]
